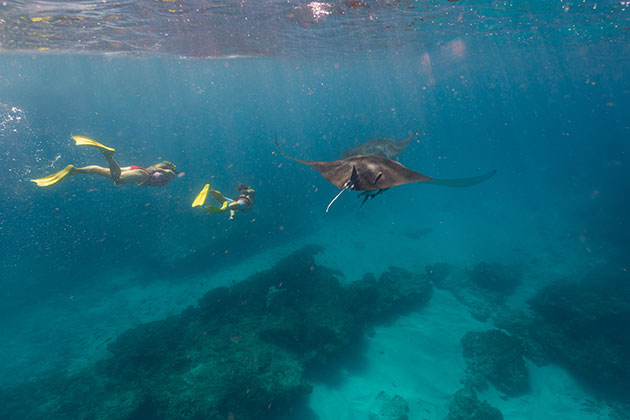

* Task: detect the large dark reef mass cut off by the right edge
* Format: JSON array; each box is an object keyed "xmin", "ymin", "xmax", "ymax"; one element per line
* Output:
[{"xmin": 497, "ymin": 267, "xmax": 630, "ymax": 401}]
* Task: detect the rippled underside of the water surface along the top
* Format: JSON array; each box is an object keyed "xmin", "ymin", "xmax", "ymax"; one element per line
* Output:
[{"xmin": 0, "ymin": 0, "xmax": 630, "ymax": 57}]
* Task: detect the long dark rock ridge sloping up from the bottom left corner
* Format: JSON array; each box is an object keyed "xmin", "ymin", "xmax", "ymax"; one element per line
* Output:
[{"xmin": 0, "ymin": 246, "xmax": 433, "ymax": 420}]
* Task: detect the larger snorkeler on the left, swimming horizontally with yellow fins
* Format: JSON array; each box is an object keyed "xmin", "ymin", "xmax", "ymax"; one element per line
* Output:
[{"xmin": 31, "ymin": 136, "xmax": 178, "ymax": 187}]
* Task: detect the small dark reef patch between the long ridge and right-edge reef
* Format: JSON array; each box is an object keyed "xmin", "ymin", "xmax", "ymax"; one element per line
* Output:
[{"xmin": 427, "ymin": 262, "xmax": 522, "ymax": 322}]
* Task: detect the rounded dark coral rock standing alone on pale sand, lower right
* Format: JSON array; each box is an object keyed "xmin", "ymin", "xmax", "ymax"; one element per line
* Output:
[{"xmin": 461, "ymin": 329, "xmax": 530, "ymax": 397}]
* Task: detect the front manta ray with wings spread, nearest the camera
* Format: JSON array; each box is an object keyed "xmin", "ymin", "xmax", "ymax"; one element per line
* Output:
[{"xmin": 276, "ymin": 137, "xmax": 496, "ymax": 213}]
